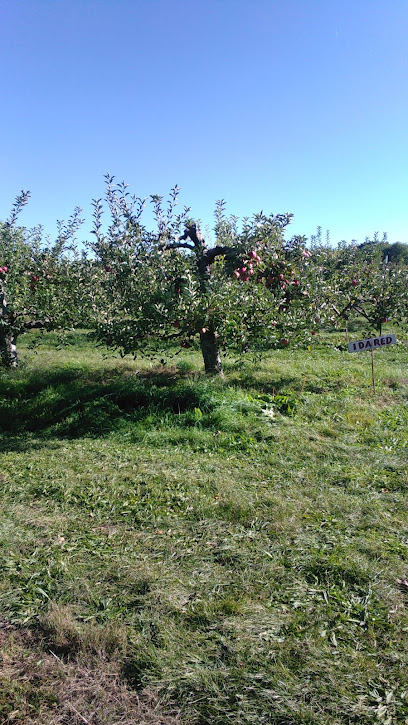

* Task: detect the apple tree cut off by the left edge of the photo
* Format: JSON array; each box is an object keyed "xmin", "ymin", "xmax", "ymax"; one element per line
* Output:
[{"xmin": 0, "ymin": 191, "xmax": 82, "ymax": 367}]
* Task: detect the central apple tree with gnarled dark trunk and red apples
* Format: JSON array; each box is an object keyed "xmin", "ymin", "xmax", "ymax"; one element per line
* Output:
[{"xmin": 91, "ymin": 176, "xmax": 316, "ymax": 374}]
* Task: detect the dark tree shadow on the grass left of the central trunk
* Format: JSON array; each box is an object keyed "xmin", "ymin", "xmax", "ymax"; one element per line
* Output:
[{"xmin": 0, "ymin": 368, "xmax": 206, "ymax": 443}]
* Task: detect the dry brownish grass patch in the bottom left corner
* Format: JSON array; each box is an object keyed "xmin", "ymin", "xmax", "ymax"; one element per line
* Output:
[{"xmin": 0, "ymin": 611, "xmax": 180, "ymax": 725}]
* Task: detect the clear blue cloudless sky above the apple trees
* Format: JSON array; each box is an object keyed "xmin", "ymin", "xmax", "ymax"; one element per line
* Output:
[{"xmin": 0, "ymin": 0, "xmax": 408, "ymax": 243}]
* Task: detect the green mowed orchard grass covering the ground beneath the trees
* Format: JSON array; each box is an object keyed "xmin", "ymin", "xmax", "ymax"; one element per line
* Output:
[{"xmin": 0, "ymin": 334, "xmax": 408, "ymax": 725}]
